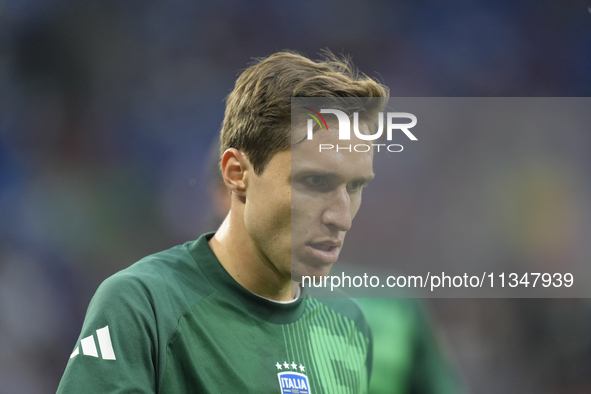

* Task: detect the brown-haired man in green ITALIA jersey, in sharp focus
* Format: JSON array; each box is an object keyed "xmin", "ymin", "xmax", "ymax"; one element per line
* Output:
[{"xmin": 58, "ymin": 52, "xmax": 388, "ymax": 394}]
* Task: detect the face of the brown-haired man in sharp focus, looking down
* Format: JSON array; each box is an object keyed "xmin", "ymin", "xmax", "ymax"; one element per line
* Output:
[{"xmin": 245, "ymin": 121, "xmax": 374, "ymax": 282}]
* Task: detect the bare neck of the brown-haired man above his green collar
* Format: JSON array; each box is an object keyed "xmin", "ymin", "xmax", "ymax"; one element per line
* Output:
[{"xmin": 209, "ymin": 211, "xmax": 298, "ymax": 301}]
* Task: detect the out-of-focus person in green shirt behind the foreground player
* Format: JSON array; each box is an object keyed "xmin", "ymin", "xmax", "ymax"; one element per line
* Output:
[{"xmin": 203, "ymin": 141, "xmax": 465, "ymax": 394}]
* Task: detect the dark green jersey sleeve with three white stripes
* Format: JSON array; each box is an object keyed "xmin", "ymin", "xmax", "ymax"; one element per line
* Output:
[{"xmin": 57, "ymin": 271, "xmax": 158, "ymax": 394}]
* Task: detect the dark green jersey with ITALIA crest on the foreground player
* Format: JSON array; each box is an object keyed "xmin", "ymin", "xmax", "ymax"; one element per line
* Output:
[{"xmin": 58, "ymin": 234, "xmax": 372, "ymax": 394}]
